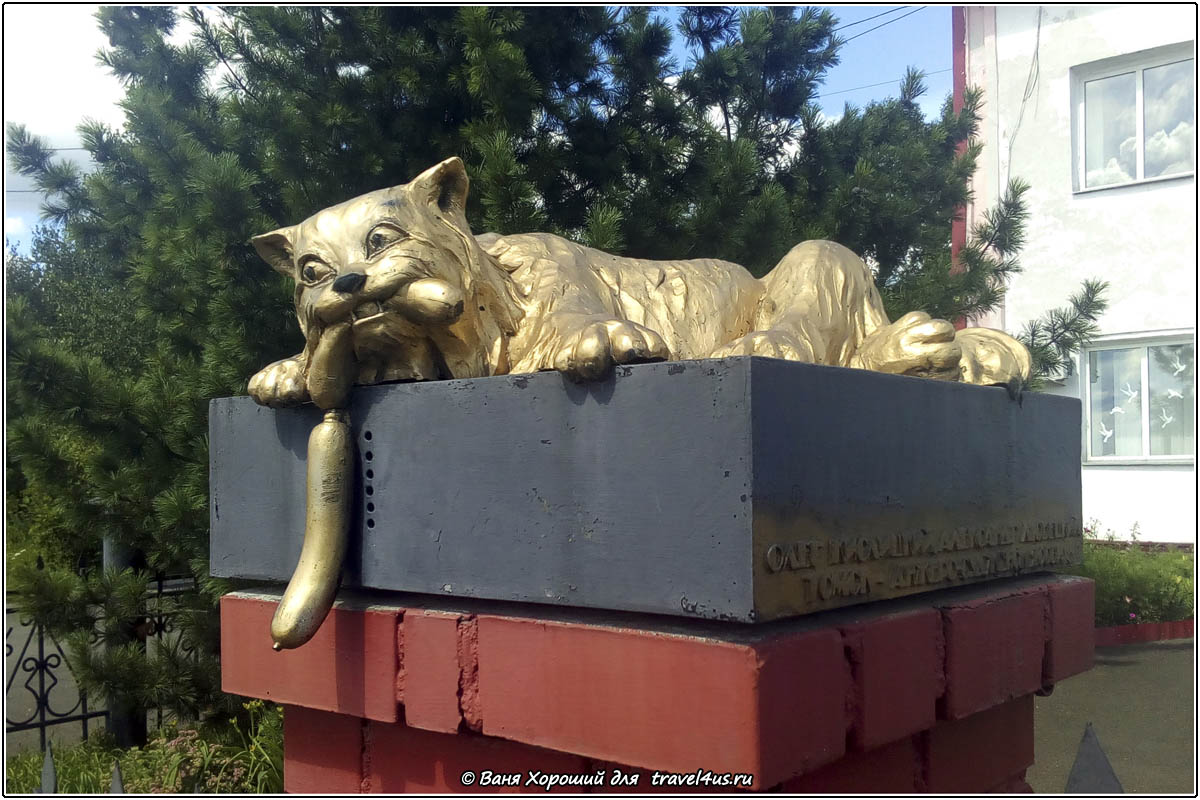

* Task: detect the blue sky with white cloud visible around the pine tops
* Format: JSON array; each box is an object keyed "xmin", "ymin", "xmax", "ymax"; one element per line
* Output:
[{"xmin": 4, "ymin": 4, "xmax": 952, "ymax": 250}]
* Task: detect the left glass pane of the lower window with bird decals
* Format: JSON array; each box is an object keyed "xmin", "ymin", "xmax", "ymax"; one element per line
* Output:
[{"xmin": 1088, "ymin": 348, "xmax": 1145, "ymax": 456}]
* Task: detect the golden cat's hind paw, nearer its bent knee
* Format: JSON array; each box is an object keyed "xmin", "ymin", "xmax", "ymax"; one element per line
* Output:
[{"xmin": 851, "ymin": 311, "xmax": 962, "ymax": 380}]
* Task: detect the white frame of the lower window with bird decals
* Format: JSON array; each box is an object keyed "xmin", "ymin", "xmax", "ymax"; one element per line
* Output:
[{"xmin": 1078, "ymin": 331, "xmax": 1196, "ymax": 467}]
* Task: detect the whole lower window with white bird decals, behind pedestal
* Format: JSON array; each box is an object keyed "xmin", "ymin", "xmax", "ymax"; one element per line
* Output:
[{"xmin": 1084, "ymin": 342, "xmax": 1196, "ymax": 463}]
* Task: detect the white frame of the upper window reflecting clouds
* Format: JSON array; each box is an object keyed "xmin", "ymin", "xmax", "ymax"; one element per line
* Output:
[{"xmin": 1070, "ymin": 41, "xmax": 1196, "ymax": 194}]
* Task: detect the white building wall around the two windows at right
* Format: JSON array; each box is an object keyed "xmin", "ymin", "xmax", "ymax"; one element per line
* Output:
[{"xmin": 965, "ymin": 4, "xmax": 1196, "ymax": 541}]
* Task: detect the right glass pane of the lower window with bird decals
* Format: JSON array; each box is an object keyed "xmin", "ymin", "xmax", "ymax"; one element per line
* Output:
[{"xmin": 1148, "ymin": 344, "xmax": 1196, "ymax": 456}]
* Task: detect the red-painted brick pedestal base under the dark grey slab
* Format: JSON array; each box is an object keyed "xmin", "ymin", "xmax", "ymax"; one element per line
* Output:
[{"xmin": 221, "ymin": 576, "xmax": 1094, "ymax": 794}]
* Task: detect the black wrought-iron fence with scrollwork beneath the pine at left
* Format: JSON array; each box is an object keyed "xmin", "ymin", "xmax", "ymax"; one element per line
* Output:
[{"xmin": 5, "ymin": 559, "xmax": 196, "ymax": 752}]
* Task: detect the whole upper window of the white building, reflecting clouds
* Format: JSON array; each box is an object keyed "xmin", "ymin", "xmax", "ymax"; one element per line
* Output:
[{"xmin": 1072, "ymin": 43, "xmax": 1195, "ymax": 191}]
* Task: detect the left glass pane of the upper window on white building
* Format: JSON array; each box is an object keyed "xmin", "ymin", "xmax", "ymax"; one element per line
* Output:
[{"xmin": 1084, "ymin": 72, "xmax": 1138, "ymax": 187}]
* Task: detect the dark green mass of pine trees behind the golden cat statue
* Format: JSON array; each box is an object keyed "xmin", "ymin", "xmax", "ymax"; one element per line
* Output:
[{"xmin": 7, "ymin": 6, "xmax": 1094, "ymax": 715}]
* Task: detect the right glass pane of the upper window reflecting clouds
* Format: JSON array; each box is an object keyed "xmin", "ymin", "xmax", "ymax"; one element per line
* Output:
[{"xmin": 1142, "ymin": 60, "xmax": 1196, "ymax": 178}]
